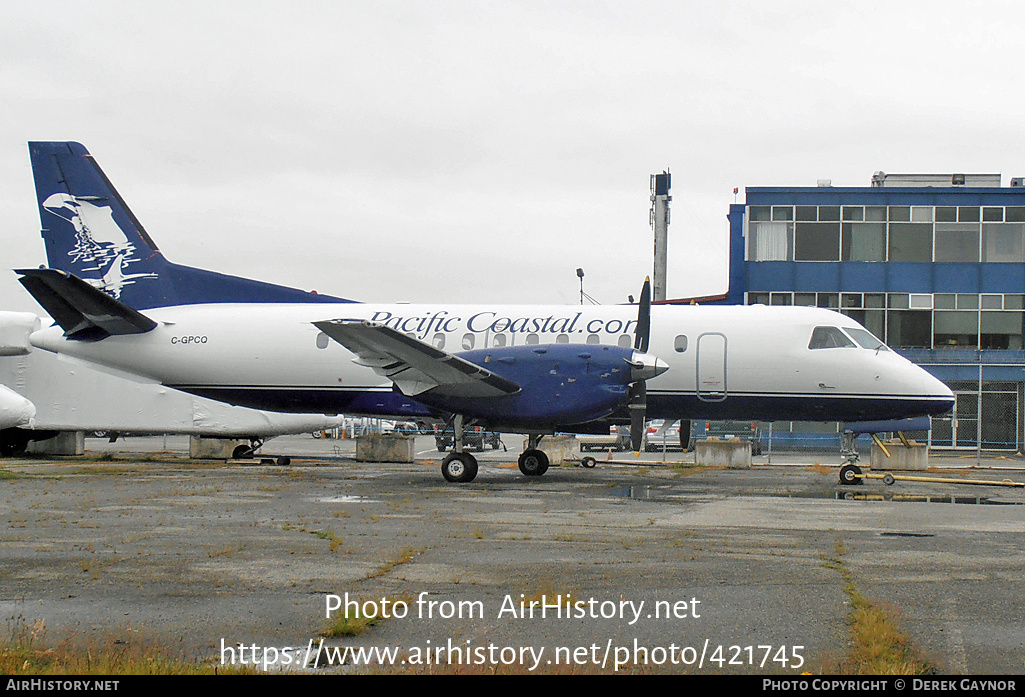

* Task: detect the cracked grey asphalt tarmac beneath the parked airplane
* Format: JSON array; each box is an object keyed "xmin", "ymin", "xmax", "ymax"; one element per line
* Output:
[{"xmin": 0, "ymin": 436, "xmax": 1025, "ymax": 673}]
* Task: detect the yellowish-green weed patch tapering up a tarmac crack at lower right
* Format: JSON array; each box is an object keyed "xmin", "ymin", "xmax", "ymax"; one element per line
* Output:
[{"xmin": 823, "ymin": 540, "xmax": 937, "ymax": 675}]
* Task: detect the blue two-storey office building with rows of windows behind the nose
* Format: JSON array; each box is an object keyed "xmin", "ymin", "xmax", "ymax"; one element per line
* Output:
[{"xmin": 727, "ymin": 172, "xmax": 1025, "ymax": 451}]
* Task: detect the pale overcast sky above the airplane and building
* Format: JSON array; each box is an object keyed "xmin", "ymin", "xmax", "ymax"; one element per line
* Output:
[{"xmin": 0, "ymin": 0, "xmax": 1025, "ymax": 312}]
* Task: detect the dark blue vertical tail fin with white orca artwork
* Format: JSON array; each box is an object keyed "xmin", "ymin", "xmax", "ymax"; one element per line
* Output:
[{"xmin": 29, "ymin": 141, "xmax": 349, "ymax": 310}]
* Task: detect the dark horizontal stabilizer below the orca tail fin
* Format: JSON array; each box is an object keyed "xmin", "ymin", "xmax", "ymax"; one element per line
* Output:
[{"xmin": 14, "ymin": 269, "xmax": 157, "ymax": 341}]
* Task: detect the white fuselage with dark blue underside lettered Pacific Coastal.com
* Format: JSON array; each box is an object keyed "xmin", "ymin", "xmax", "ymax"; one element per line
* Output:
[{"xmin": 32, "ymin": 303, "xmax": 953, "ymax": 421}]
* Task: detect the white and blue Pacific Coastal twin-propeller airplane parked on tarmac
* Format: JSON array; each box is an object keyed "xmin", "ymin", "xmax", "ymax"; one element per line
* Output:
[{"xmin": 18, "ymin": 142, "xmax": 953, "ymax": 482}]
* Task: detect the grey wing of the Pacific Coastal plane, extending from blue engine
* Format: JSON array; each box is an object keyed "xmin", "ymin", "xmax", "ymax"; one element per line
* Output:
[{"xmin": 314, "ymin": 320, "xmax": 520, "ymax": 398}]
